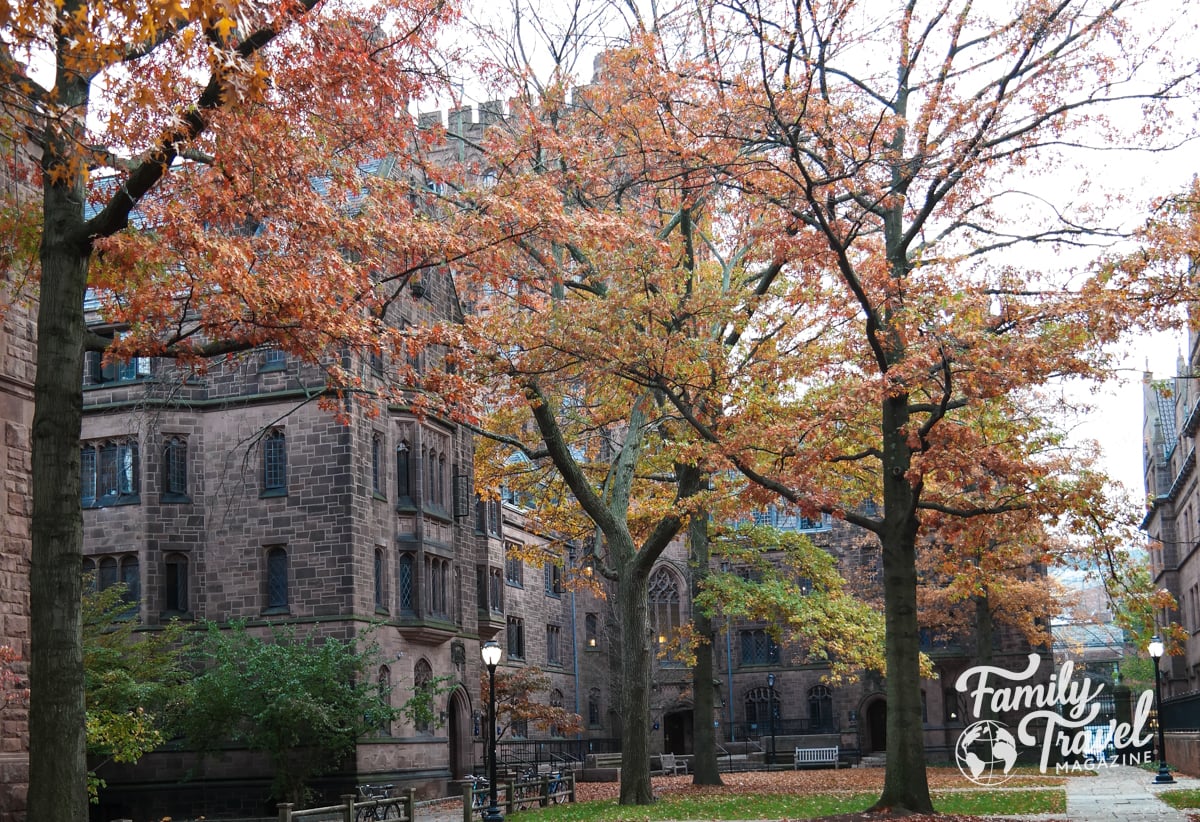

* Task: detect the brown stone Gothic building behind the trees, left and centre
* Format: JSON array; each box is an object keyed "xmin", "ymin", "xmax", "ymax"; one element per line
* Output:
[{"xmin": 0, "ymin": 107, "xmax": 1051, "ymax": 822}]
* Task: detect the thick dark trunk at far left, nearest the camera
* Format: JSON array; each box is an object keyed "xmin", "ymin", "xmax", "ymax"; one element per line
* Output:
[{"xmin": 29, "ymin": 147, "xmax": 89, "ymax": 822}]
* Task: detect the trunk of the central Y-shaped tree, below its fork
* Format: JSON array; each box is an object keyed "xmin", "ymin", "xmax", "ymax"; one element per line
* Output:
[{"xmin": 617, "ymin": 562, "xmax": 654, "ymax": 805}]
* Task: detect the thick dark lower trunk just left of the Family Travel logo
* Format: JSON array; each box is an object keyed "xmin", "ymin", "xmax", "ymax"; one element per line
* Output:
[{"xmin": 875, "ymin": 395, "xmax": 934, "ymax": 812}]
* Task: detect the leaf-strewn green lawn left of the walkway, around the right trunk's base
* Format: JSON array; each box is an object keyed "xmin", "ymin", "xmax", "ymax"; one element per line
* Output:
[{"xmin": 521, "ymin": 787, "xmax": 1067, "ymax": 822}]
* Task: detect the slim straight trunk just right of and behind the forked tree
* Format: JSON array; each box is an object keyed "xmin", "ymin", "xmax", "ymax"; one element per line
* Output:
[{"xmin": 688, "ymin": 512, "xmax": 715, "ymax": 785}]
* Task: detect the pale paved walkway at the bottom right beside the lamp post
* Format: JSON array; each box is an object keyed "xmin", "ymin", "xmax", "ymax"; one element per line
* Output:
[{"xmin": 1067, "ymin": 764, "xmax": 1200, "ymax": 822}]
